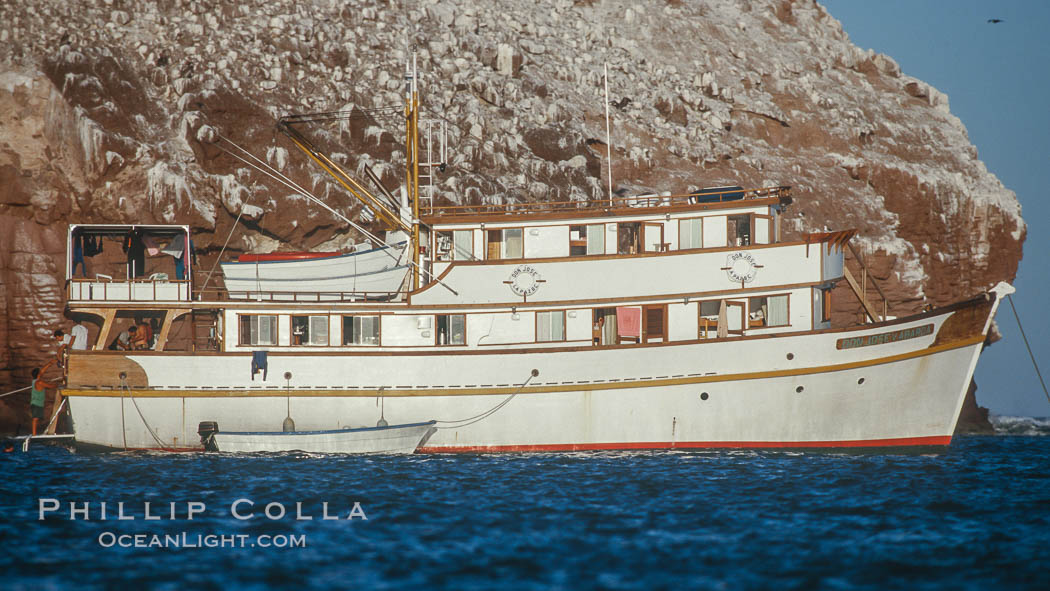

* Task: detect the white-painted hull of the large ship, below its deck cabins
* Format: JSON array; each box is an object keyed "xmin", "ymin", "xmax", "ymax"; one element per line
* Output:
[{"xmin": 70, "ymin": 300, "xmax": 999, "ymax": 451}]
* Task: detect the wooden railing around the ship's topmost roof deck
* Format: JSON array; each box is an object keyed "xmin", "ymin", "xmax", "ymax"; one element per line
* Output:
[{"xmin": 424, "ymin": 186, "xmax": 791, "ymax": 217}]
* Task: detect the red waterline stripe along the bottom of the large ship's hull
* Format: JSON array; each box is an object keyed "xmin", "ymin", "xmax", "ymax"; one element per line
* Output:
[{"xmin": 416, "ymin": 436, "xmax": 951, "ymax": 453}]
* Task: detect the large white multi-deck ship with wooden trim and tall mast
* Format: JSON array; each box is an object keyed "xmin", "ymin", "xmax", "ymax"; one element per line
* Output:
[{"xmin": 53, "ymin": 63, "xmax": 1013, "ymax": 452}]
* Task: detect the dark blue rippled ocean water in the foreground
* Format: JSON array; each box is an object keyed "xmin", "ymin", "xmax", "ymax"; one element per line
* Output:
[{"xmin": 0, "ymin": 429, "xmax": 1050, "ymax": 590}]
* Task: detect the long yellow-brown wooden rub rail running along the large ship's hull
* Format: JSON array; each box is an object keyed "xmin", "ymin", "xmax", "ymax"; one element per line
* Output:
[{"xmin": 62, "ymin": 335, "xmax": 985, "ymax": 398}]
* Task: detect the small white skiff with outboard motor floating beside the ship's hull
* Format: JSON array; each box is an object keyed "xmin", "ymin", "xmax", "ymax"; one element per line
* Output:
[{"xmin": 202, "ymin": 421, "xmax": 435, "ymax": 453}]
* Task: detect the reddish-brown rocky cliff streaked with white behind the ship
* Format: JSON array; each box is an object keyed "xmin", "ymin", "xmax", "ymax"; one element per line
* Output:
[{"xmin": 0, "ymin": 0, "xmax": 1025, "ymax": 434}]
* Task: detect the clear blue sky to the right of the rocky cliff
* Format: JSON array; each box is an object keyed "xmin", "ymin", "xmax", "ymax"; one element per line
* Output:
[{"xmin": 821, "ymin": 0, "xmax": 1050, "ymax": 417}]
